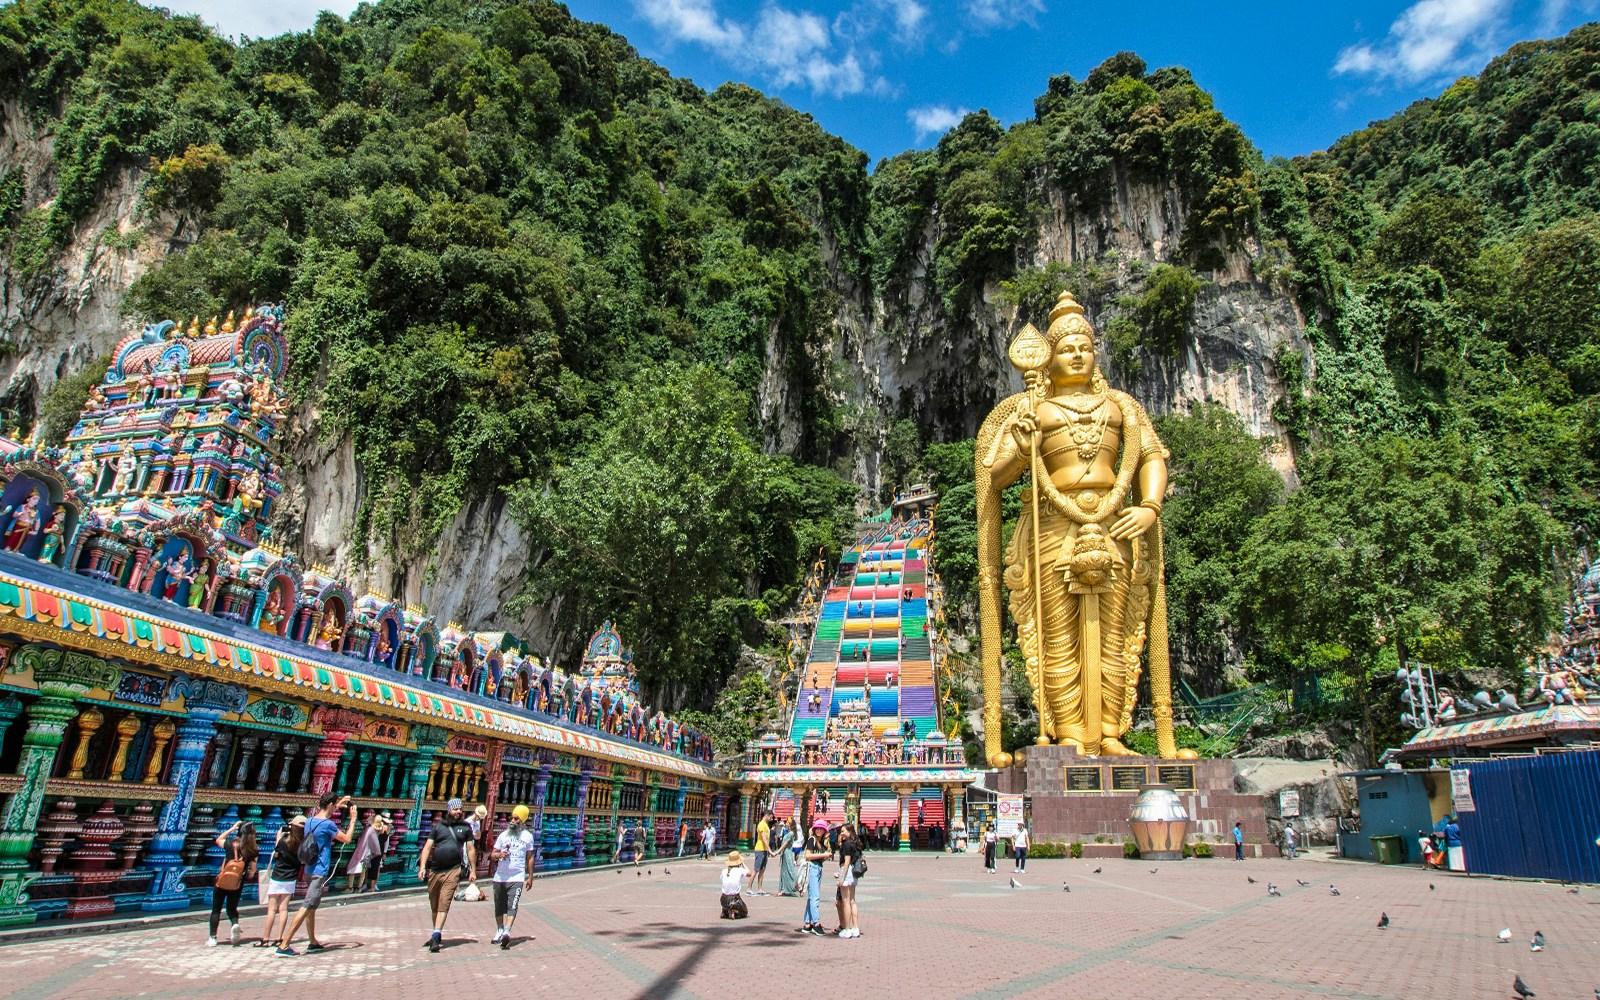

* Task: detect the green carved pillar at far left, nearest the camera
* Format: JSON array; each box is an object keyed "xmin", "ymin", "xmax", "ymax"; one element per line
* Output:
[{"xmin": 0, "ymin": 643, "xmax": 122, "ymax": 926}]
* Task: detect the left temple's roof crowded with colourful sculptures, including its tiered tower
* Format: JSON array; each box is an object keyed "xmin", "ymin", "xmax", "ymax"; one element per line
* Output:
[{"xmin": 0, "ymin": 306, "xmax": 712, "ymax": 760}]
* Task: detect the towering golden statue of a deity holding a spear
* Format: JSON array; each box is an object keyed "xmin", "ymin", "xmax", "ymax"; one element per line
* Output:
[{"xmin": 976, "ymin": 293, "xmax": 1192, "ymax": 766}]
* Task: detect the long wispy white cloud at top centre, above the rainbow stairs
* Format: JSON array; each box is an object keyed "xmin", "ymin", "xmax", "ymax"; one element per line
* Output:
[{"xmin": 634, "ymin": 0, "xmax": 883, "ymax": 98}]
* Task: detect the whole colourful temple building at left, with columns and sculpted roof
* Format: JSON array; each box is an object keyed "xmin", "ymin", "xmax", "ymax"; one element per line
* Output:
[{"xmin": 0, "ymin": 306, "xmax": 730, "ymax": 925}]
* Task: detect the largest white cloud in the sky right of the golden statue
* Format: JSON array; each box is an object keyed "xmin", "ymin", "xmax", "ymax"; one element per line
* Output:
[{"xmin": 1333, "ymin": 0, "xmax": 1510, "ymax": 83}]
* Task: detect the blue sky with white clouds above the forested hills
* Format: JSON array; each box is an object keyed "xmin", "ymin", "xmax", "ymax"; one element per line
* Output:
[{"xmin": 175, "ymin": 0, "xmax": 1600, "ymax": 163}]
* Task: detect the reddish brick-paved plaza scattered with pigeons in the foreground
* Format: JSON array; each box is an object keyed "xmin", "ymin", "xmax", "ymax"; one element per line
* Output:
[{"xmin": 0, "ymin": 854, "xmax": 1600, "ymax": 1000}]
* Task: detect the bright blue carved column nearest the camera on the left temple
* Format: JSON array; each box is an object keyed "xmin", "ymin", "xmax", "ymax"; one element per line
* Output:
[{"xmin": 141, "ymin": 674, "xmax": 250, "ymax": 912}]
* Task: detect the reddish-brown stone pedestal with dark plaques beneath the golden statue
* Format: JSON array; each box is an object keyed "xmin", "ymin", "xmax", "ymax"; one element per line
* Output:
[{"xmin": 995, "ymin": 746, "xmax": 1278, "ymax": 858}]
